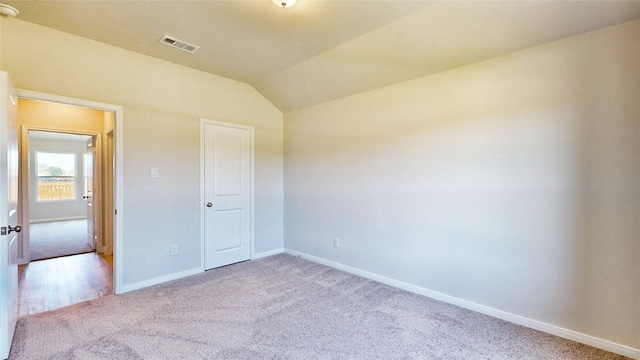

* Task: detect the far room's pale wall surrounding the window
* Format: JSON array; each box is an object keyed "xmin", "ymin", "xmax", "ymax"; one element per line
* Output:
[{"xmin": 29, "ymin": 139, "xmax": 87, "ymax": 223}]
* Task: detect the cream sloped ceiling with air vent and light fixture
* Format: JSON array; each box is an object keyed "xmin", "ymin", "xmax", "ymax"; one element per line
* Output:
[{"xmin": 4, "ymin": 0, "xmax": 640, "ymax": 112}]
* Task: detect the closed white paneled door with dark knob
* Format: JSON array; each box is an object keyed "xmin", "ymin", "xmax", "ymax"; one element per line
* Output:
[{"xmin": 202, "ymin": 121, "xmax": 253, "ymax": 270}]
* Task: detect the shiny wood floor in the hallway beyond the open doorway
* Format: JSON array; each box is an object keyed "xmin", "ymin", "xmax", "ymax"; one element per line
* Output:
[{"xmin": 18, "ymin": 252, "xmax": 113, "ymax": 316}]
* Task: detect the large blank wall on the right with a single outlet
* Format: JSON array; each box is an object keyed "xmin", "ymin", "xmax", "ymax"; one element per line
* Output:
[{"xmin": 285, "ymin": 21, "xmax": 640, "ymax": 349}]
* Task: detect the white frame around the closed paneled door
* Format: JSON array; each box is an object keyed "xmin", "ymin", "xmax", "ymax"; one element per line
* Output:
[{"xmin": 200, "ymin": 118, "xmax": 255, "ymax": 272}]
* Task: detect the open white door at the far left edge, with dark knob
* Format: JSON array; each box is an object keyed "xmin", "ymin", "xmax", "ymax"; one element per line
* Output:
[{"xmin": 0, "ymin": 72, "xmax": 20, "ymax": 359}]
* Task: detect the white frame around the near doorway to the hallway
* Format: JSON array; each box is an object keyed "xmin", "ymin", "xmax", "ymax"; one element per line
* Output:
[{"xmin": 17, "ymin": 89, "xmax": 124, "ymax": 294}]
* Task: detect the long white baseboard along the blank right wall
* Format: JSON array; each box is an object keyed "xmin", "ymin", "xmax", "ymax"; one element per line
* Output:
[{"xmin": 284, "ymin": 249, "xmax": 640, "ymax": 359}]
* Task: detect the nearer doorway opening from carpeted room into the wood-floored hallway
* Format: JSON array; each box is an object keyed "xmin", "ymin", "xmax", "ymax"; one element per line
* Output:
[{"xmin": 18, "ymin": 91, "xmax": 122, "ymax": 315}]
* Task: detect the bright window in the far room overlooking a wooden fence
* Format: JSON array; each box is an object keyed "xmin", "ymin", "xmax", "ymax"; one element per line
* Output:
[{"xmin": 36, "ymin": 152, "xmax": 76, "ymax": 201}]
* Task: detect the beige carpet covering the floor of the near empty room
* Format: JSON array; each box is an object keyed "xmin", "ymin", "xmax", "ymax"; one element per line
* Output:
[{"xmin": 10, "ymin": 254, "xmax": 623, "ymax": 360}]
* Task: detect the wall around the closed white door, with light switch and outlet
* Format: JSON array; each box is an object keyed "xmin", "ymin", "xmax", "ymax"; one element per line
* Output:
[{"xmin": 0, "ymin": 18, "xmax": 283, "ymax": 287}]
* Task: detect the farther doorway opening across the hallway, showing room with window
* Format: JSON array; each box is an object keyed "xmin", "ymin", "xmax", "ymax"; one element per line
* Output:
[{"xmin": 28, "ymin": 130, "xmax": 95, "ymax": 261}]
